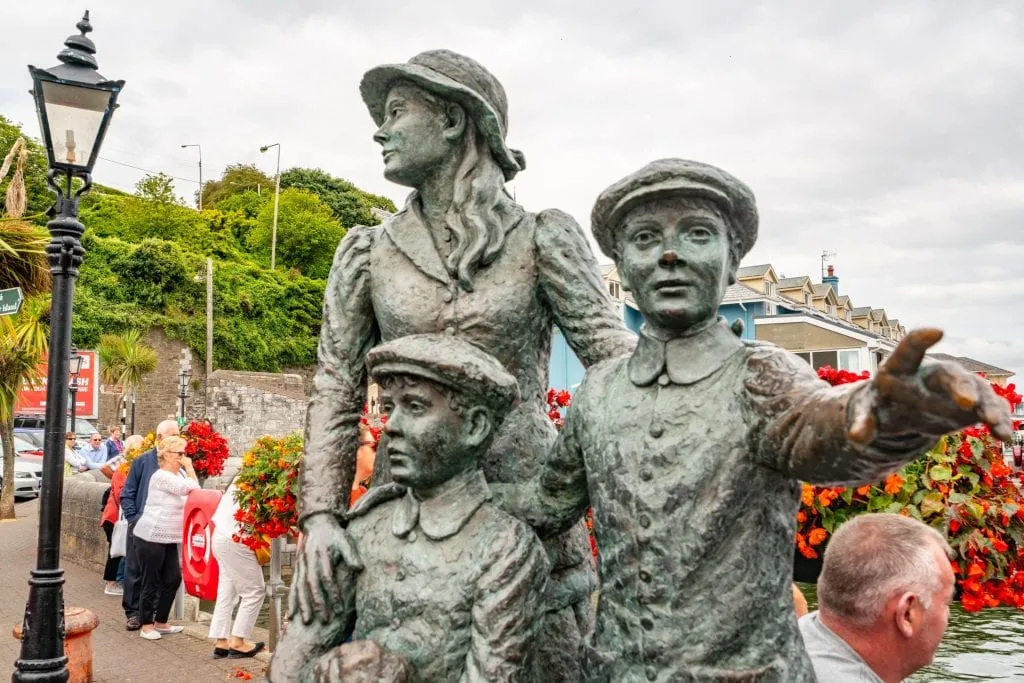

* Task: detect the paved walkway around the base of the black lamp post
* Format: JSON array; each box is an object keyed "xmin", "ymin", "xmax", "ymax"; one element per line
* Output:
[{"xmin": 0, "ymin": 501, "xmax": 266, "ymax": 683}]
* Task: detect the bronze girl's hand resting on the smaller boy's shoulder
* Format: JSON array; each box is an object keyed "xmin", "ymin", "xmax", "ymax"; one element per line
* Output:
[{"xmin": 289, "ymin": 513, "xmax": 362, "ymax": 624}]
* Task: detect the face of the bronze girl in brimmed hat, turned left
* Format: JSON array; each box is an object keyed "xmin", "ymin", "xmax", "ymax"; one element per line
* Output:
[{"xmin": 374, "ymin": 85, "xmax": 453, "ymax": 187}]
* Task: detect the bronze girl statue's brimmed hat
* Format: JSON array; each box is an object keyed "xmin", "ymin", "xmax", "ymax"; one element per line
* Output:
[{"xmin": 359, "ymin": 50, "xmax": 526, "ymax": 180}]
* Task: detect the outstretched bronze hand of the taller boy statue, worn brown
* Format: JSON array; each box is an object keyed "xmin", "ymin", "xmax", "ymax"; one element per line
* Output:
[{"xmin": 850, "ymin": 328, "xmax": 1014, "ymax": 443}]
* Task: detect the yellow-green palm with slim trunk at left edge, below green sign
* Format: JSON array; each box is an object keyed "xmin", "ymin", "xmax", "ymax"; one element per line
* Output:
[{"xmin": 0, "ymin": 302, "xmax": 48, "ymax": 519}]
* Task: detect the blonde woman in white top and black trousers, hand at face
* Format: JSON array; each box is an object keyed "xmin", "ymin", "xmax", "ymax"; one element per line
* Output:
[{"xmin": 134, "ymin": 436, "xmax": 199, "ymax": 640}]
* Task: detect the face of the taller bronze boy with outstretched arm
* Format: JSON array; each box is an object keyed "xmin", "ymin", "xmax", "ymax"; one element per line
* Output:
[{"xmin": 616, "ymin": 197, "xmax": 733, "ymax": 335}]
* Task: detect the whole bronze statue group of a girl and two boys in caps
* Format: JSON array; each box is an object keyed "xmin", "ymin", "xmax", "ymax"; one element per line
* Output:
[{"xmin": 269, "ymin": 50, "xmax": 1011, "ymax": 682}]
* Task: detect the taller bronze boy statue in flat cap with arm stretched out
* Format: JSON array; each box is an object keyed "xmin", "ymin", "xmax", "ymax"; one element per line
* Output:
[{"xmin": 502, "ymin": 159, "xmax": 1012, "ymax": 683}]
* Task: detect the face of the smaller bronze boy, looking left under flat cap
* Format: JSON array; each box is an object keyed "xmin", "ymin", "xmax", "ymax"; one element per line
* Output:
[{"xmin": 381, "ymin": 378, "xmax": 476, "ymax": 490}]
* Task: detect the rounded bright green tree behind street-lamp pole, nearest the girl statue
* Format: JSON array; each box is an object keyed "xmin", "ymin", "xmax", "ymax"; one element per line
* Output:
[{"xmin": 247, "ymin": 188, "xmax": 345, "ymax": 280}]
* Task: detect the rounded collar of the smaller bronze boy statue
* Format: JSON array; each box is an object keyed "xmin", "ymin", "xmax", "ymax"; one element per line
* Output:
[{"xmin": 391, "ymin": 470, "xmax": 490, "ymax": 541}]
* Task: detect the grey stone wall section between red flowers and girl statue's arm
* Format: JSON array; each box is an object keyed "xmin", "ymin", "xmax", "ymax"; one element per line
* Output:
[{"xmin": 206, "ymin": 370, "xmax": 308, "ymax": 457}]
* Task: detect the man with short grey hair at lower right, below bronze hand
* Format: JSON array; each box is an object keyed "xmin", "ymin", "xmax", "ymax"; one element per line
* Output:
[{"xmin": 800, "ymin": 513, "xmax": 954, "ymax": 683}]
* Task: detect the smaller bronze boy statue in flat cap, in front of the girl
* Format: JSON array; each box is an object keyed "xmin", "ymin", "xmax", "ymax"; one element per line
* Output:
[{"xmin": 269, "ymin": 334, "xmax": 549, "ymax": 682}]
